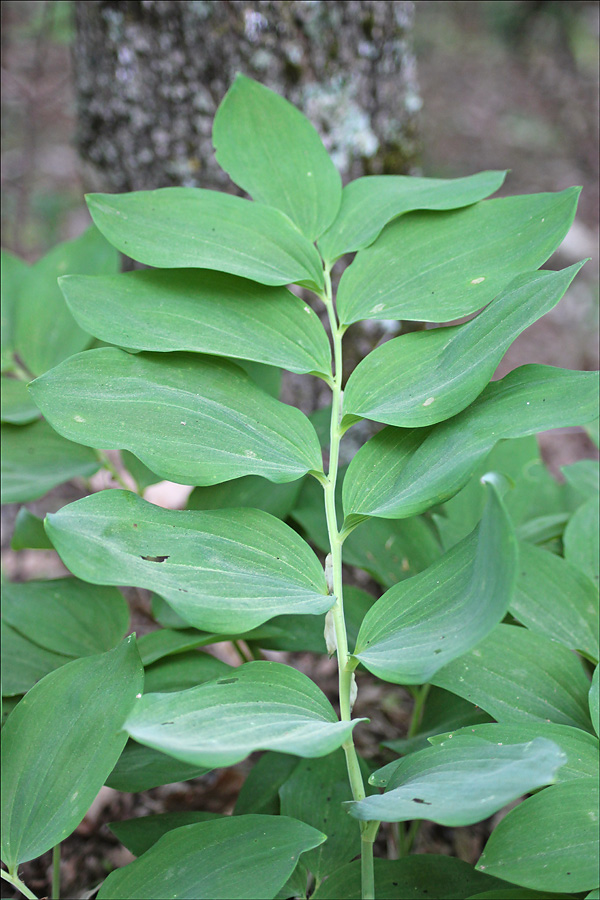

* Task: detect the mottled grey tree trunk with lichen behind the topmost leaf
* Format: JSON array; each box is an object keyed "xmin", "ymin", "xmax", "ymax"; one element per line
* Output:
[{"xmin": 74, "ymin": 0, "xmax": 420, "ymax": 191}]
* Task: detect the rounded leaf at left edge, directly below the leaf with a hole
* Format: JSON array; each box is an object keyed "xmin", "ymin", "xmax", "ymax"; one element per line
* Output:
[{"xmin": 2, "ymin": 578, "xmax": 129, "ymax": 657}]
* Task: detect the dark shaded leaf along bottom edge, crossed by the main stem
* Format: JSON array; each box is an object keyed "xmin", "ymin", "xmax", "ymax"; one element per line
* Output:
[{"xmin": 312, "ymin": 853, "xmax": 508, "ymax": 900}]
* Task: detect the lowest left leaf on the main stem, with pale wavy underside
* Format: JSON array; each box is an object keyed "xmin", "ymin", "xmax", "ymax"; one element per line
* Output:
[{"xmin": 125, "ymin": 662, "xmax": 360, "ymax": 768}]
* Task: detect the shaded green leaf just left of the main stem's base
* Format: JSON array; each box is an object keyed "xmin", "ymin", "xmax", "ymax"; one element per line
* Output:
[{"xmin": 279, "ymin": 748, "xmax": 360, "ymax": 883}]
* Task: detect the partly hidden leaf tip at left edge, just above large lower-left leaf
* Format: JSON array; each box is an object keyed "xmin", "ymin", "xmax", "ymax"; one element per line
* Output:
[{"xmin": 2, "ymin": 621, "xmax": 71, "ymax": 697}]
